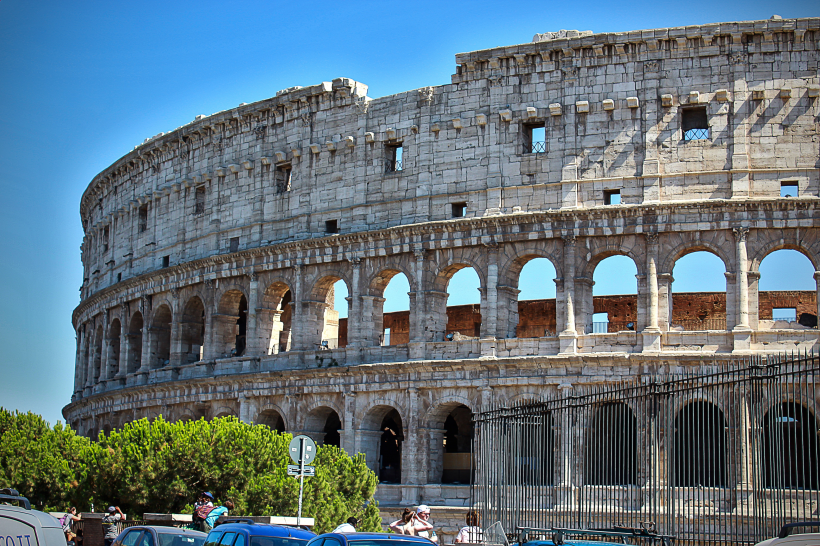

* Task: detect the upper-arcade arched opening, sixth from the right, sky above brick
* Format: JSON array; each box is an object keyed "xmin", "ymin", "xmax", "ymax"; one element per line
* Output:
[{"xmin": 370, "ymin": 269, "xmax": 410, "ymax": 345}]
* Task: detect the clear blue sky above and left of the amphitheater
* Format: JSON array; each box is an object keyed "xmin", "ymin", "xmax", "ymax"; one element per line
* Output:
[{"xmin": 0, "ymin": 0, "xmax": 820, "ymax": 422}]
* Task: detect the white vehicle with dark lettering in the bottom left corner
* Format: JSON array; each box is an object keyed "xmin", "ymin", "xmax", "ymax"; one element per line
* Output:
[{"xmin": 0, "ymin": 489, "xmax": 65, "ymax": 546}]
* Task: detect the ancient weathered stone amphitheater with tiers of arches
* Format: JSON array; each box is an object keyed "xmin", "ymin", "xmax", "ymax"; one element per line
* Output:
[{"xmin": 64, "ymin": 15, "xmax": 820, "ymax": 505}]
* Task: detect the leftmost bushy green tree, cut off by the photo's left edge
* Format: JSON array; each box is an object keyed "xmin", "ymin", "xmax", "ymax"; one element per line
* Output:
[{"xmin": 0, "ymin": 408, "xmax": 91, "ymax": 510}]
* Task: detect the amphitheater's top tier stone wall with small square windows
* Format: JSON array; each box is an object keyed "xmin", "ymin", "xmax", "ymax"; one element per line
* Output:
[{"xmin": 80, "ymin": 18, "xmax": 820, "ymax": 299}]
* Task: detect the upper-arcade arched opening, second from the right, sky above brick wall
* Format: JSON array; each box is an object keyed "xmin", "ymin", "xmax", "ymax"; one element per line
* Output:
[{"xmin": 669, "ymin": 251, "xmax": 726, "ymax": 331}]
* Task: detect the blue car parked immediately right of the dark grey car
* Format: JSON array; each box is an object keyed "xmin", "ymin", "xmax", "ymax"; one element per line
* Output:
[{"xmin": 205, "ymin": 518, "xmax": 316, "ymax": 546}]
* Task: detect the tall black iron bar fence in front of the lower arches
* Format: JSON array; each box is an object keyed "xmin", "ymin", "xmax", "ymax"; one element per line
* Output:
[{"xmin": 472, "ymin": 355, "xmax": 820, "ymax": 544}]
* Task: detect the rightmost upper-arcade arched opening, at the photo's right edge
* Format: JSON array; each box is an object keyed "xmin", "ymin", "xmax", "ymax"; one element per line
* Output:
[{"xmin": 750, "ymin": 249, "xmax": 817, "ymax": 330}]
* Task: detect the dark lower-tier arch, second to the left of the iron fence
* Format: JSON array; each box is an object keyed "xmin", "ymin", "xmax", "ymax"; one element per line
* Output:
[{"xmin": 359, "ymin": 402, "xmax": 404, "ymax": 483}]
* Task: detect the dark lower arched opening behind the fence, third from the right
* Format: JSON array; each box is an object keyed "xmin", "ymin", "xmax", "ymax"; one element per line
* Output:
[{"xmin": 584, "ymin": 402, "xmax": 638, "ymax": 485}]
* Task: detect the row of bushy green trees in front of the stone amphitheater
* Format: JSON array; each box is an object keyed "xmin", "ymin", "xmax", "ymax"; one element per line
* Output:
[{"xmin": 0, "ymin": 408, "xmax": 380, "ymax": 532}]
